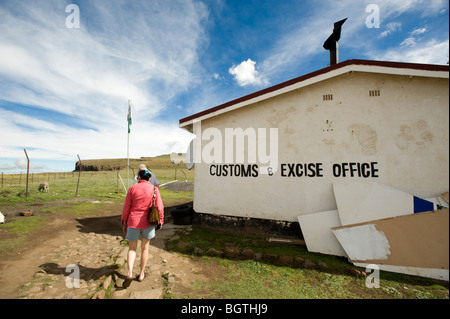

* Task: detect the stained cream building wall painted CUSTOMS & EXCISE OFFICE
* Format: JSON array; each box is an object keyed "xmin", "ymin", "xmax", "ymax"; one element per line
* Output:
[{"xmin": 194, "ymin": 72, "xmax": 449, "ymax": 221}]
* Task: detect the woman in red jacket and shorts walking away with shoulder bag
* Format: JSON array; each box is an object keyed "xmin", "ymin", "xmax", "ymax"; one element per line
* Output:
[{"xmin": 121, "ymin": 170, "xmax": 164, "ymax": 288}]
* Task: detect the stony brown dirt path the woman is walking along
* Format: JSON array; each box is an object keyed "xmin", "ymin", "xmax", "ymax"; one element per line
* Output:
[{"xmin": 0, "ymin": 204, "xmax": 208, "ymax": 299}]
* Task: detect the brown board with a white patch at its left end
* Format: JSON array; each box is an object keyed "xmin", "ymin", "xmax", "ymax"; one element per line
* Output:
[{"xmin": 332, "ymin": 208, "xmax": 449, "ymax": 280}]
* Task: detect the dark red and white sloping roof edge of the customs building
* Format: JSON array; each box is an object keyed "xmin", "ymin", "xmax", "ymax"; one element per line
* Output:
[{"xmin": 179, "ymin": 60, "xmax": 449, "ymax": 133}]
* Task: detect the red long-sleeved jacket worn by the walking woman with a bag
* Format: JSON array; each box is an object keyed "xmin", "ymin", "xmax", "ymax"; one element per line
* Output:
[{"xmin": 121, "ymin": 180, "xmax": 164, "ymax": 229}]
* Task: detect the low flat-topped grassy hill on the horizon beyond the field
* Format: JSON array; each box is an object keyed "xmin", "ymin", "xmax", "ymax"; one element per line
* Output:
[{"xmin": 74, "ymin": 154, "xmax": 186, "ymax": 171}]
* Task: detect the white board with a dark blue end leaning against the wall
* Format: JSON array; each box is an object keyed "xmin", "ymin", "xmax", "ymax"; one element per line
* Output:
[{"xmin": 333, "ymin": 182, "xmax": 437, "ymax": 226}]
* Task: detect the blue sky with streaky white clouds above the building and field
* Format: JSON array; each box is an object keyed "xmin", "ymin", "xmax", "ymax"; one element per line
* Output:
[{"xmin": 0, "ymin": 0, "xmax": 449, "ymax": 173}]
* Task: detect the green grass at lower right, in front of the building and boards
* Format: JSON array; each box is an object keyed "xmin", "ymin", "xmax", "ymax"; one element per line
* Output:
[{"xmin": 169, "ymin": 226, "xmax": 448, "ymax": 299}]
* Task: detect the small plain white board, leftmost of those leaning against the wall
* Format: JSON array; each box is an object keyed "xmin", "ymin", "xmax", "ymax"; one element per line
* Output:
[{"xmin": 297, "ymin": 210, "xmax": 347, "ymax": 257}]
